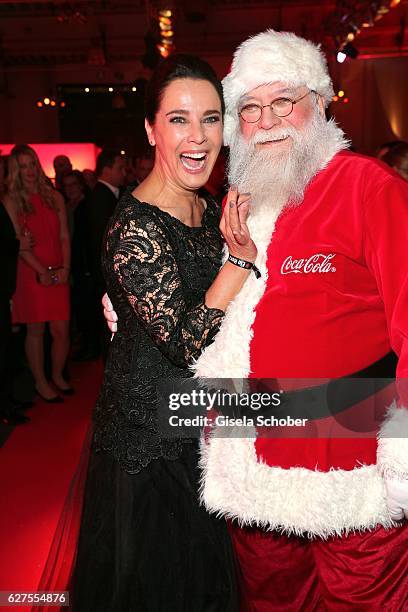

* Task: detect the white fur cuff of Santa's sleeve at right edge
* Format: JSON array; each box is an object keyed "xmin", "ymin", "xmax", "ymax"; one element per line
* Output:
[{"xmin": 377, "ymin": 402, "xmax": 408, "ymax": 479}]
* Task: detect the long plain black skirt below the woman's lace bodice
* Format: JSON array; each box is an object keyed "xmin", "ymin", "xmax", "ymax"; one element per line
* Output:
[{"xmin": 69, "ymin": 443, "xmax": 239, "ymax": 612}]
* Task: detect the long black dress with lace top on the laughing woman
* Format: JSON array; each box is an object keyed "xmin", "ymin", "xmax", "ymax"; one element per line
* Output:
[{"xmin": 70, "ymin": 193, "xmax": 239, "ymax": 612}]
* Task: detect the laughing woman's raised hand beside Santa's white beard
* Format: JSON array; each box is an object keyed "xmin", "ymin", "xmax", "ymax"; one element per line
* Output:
[{"xmin": 220, "ymin": 185, "xmax": 258, "ymax": 263}]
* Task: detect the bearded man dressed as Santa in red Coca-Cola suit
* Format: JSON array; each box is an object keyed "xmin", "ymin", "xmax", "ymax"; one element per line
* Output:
[{"xmin": 194, "ymin": 30, "xmax": 408, "ymax": 612}]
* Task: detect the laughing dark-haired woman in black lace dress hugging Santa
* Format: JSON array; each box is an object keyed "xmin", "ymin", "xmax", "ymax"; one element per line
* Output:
[{"xmin": 71, "ymin": 55, "xmax": 256, "ymax": 612}]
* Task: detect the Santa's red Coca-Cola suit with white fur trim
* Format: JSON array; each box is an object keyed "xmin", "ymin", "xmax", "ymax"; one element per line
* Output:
[{"xmin": 195, "ymin": 151, "xmax": 408, "ymax": 612}]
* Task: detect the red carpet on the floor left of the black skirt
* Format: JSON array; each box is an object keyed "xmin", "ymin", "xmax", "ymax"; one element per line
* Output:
[{"xmin": 0, "ymin": 362, "xmax": 102, "ymax": 611}]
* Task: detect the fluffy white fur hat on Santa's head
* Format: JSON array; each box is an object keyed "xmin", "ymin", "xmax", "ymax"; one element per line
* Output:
[{"xmin": 222, "ymin": 30, "xmax": 334, "ymax": 145}]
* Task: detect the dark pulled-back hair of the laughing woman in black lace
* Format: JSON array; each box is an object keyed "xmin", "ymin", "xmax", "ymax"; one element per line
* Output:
[{"xmin": 145, "ymin": 53, "xmax": 225, "ymax": 125}]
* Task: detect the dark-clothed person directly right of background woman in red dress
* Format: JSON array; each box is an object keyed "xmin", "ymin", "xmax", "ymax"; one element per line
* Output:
[{"xmin": 62, "ymin": 170, "xmax": 99, "ymax": 361}]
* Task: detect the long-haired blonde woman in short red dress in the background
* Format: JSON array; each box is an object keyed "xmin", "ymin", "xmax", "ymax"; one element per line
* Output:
[{"xmin": 4, "ymin": 145, "xmax": 72, "ymax": 403}]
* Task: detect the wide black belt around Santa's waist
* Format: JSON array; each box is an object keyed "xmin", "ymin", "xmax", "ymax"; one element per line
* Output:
[{"xmin": 250, "ymin": 352, "xmax": 398, "ymax": 420}]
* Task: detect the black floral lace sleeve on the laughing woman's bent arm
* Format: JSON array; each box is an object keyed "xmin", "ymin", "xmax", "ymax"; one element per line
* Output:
[{"xmin": 113, "ymin": 216, "xmax": 224, "ymax": 367}]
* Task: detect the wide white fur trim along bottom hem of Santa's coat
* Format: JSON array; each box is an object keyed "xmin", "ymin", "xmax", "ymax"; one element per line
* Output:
[{"xmin": 201, "ymin": 431, "xmax": 393, "ymax": 538}]
